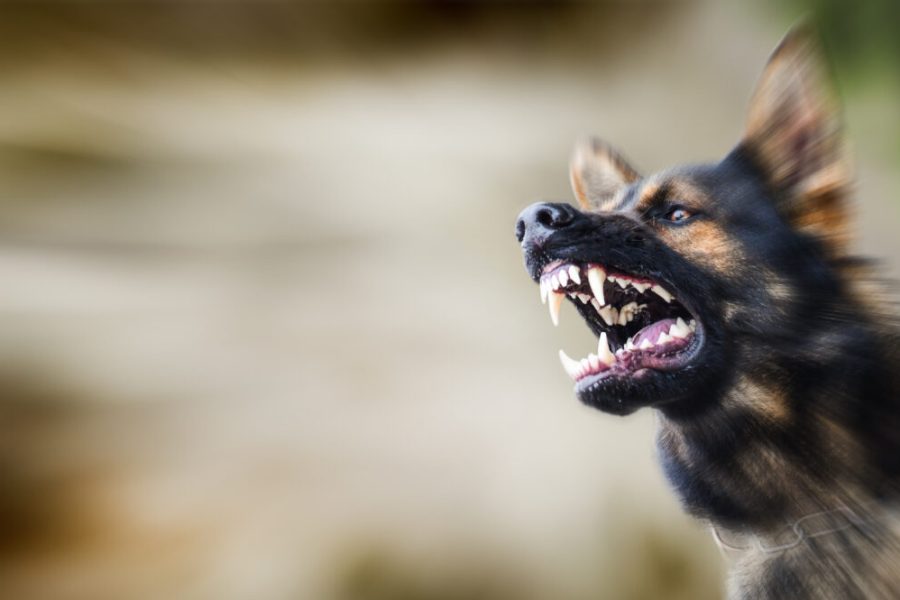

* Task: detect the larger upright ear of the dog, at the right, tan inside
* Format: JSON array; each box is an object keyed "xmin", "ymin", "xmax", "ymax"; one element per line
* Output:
[{"xmin": 741, "ymin": 25, "xmax": 851, "ymax": 251}]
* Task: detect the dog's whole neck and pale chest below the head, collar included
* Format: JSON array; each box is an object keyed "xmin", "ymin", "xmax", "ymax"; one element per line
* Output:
[{"xmin": 657, "ymin": 318, "xmax": 900, "ymax": 599}]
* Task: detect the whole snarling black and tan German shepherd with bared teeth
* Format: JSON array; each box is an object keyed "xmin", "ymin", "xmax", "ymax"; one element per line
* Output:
[{"xmin": 516, "ymin": 26, "xmax": 900, "ymax": 600}]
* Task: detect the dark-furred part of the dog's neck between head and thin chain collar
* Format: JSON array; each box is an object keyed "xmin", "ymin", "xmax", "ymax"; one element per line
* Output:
[{"xmin": 657, "ymin": 308, "xmax": 900, "ymax": 533}]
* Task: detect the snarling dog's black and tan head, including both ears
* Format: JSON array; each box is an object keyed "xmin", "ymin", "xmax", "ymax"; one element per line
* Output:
[{"xmin": 516, "ymin": 29, "xmax": 849, "ymax": 414}]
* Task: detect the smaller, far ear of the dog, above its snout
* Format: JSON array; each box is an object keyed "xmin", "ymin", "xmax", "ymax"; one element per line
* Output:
[{"xmin": 569, "ymin": 137, "xmax": 640, "ymax": 210}]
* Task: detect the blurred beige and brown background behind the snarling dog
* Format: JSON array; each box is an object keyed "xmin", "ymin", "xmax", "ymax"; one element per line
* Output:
[{"xmin": 0, "ymin": 0, "xmax": 900, "ymax": 600}]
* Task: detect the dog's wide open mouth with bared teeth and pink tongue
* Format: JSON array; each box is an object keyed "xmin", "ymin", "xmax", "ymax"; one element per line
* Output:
[{"xmin": 540, "ymin": 260, "xmax": 703, "ymax": 392}]
